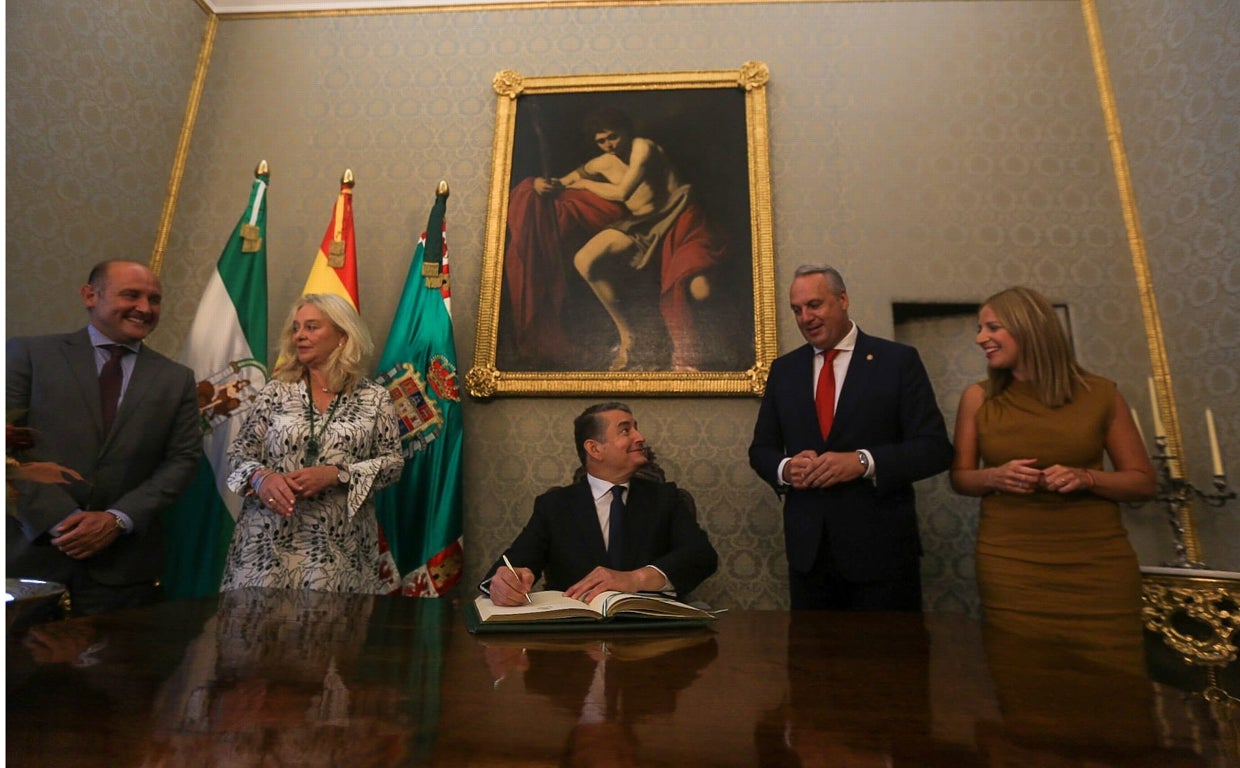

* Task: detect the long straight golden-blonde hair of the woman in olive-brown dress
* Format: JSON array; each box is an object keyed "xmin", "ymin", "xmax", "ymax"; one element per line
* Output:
[{"xmin": 983, "ymin": 285, "xmax": 1085, "ymax": 408}]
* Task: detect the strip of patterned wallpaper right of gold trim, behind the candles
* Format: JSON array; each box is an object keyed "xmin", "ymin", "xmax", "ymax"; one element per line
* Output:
[{"xmin": 1099, "ymin": 0, "xmax": 1240, "ymax": 569}]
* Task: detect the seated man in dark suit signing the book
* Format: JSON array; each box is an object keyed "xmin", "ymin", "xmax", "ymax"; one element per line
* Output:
[{"xmin": 481, "ymin": 402, "xmax": 719, "ymax": 605}]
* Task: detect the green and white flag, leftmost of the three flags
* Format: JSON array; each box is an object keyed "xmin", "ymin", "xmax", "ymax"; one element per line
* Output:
[{"xmin": 164, "ymin": 160, "xmax": 269, "ymax": 599}]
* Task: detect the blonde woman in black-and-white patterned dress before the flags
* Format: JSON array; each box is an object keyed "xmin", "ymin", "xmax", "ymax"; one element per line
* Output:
[{"xmin": 221, "ymin": 294, "xmax": 403, "ymax": 593}]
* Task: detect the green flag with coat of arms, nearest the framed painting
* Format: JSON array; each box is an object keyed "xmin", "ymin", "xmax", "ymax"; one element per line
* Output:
[{"xmin": 376, "ymin": 181, "xmax": 464, "ymax": 597}]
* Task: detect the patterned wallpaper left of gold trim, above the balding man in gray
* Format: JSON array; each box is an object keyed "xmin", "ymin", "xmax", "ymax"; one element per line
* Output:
[{"xmin": 5, "ymin": 0, "xmax": 203, "ymax": 330}]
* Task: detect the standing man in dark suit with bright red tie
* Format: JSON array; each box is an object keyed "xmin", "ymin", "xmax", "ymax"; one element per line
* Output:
[{"xmin": 749, "ymin": 264, "xmax": 952, "ymax": 610}]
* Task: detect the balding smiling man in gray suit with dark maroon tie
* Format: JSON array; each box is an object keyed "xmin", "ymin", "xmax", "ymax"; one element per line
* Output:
[{"xmin": 5, "ymin": 261, "xmax": 202, "ymax": 615}]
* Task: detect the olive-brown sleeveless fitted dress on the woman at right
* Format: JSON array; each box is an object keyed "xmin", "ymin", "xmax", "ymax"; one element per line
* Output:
[{"xmin": 977, "ymin": 375, "xmax": 1141, "ymax": 648}]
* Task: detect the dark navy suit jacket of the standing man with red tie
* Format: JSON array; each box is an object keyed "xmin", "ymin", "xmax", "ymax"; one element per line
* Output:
[{"xmin": 749, "ymin": 330, "xmax": 952, "ymax": 581}]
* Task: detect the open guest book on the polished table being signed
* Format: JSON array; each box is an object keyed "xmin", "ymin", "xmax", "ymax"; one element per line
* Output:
[{"xmin": 465, "ymin": 589, "xmax": 715, "ymax": 633}]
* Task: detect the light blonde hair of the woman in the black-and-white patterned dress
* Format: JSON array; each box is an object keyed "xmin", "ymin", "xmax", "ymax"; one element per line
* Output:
[{"xmin": 272, "ymin": 293, "xmax": 374, "ymax": 392}]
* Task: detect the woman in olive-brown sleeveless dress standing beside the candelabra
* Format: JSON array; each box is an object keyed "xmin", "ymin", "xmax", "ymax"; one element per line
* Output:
[{"xmin": 951, "ymin": 288, "xmax": 1154, "ymax": 635}]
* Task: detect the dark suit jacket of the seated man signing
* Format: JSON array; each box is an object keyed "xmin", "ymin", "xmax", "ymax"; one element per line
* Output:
[{"xmin": 487, "ymin": 478, "xmax": 719, "ymax": 598}]
